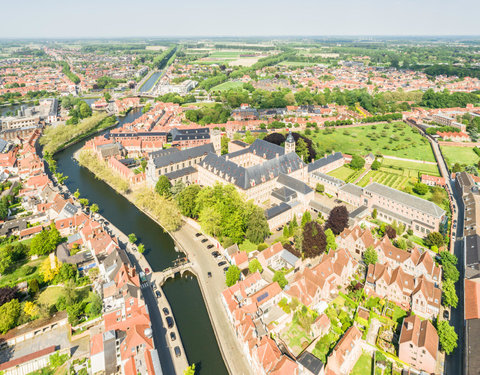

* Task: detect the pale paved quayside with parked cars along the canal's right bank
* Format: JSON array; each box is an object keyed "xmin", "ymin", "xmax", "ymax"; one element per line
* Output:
[{"xmin": 74, "ymin": 153, "xmax": 251, "ymax": 375}]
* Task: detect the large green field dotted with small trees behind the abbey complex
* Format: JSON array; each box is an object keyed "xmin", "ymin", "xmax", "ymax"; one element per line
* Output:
[{"xmin": 307, "ymin": 122, "xmax": 435, "ymax": 161}]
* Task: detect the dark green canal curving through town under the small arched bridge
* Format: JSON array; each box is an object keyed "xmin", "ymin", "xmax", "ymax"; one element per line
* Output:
[{"xmin": 55, "ymin": 110, "xmax": 228, "ymax": 375}]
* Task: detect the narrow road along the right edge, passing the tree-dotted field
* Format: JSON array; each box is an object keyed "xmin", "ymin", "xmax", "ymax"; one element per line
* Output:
[{"xmin": 420, "ymin": 122, "xmax": 465, "ymax": 375}]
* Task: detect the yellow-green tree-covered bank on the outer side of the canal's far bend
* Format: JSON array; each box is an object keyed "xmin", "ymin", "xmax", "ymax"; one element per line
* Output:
[{"xmin": 40, "ymin": 113, "xmax": 116, "ymax": 155}]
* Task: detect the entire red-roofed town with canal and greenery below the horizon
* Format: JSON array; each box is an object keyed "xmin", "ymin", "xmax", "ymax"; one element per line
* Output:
[{"xmin": 0, "ymin": 38, "xmax": 480, "ymax": 375}]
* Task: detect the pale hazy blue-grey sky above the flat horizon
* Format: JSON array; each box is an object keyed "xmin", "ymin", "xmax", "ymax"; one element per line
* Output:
[{"xmin": 0, "ymin": 0, "xmax": 480, "ymax": 38}]
